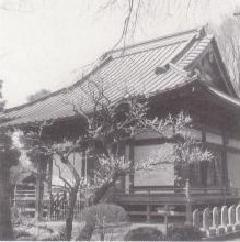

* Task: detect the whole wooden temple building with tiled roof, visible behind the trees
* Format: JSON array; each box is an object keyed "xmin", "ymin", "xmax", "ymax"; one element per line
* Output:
[{"xmin": 0, "ymin": 29, "xmax": 240, "ymax": 219}]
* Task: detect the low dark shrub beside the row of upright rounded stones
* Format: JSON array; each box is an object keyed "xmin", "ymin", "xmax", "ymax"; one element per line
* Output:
[{"xmin": 168, "ymin": 227, "xmax": 201, "ymax": 241}]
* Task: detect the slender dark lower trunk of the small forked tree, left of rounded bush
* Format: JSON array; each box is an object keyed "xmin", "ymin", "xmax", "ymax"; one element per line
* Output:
[{"xmin": 66, "ymin": 185, "xmax": 79, "ymax": 241}]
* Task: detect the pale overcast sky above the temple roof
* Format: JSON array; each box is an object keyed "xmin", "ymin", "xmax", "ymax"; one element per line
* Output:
[{"xmin": 0, "ymin": 0, "xmax": 240, "ymax": 107}]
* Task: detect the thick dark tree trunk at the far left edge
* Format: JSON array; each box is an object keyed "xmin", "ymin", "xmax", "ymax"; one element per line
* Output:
[{"xmin": 0, "ymin": 164, "xmax": 14, "ymax": 240}]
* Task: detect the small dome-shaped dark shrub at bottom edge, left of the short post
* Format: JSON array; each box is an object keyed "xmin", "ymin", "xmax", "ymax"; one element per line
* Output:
[{"xmin": 124, "ymin": 227, "xmax": 163, "ymax": 241}]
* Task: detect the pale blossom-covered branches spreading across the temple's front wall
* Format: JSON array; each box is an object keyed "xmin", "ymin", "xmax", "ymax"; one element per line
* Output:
[{"xmin": 91, "ymin": 108, "xmax": 214, "ymax": 192}]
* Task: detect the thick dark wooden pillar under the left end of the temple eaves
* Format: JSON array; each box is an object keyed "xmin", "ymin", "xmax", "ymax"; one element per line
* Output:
[{"xmin": 35, "ymin": 156, "xmax": 47, "ymax": 221}]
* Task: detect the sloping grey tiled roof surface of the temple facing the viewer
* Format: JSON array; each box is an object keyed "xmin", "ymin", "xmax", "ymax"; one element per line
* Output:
[{"xmin": 0, "ymin": 30, "xmax": 218, "ymax": 125}]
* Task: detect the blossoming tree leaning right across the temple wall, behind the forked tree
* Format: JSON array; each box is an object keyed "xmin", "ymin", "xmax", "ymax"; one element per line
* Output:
[{"xmin": 78, "ymin": 97, "xmax": 214, "ymax": 240}]
